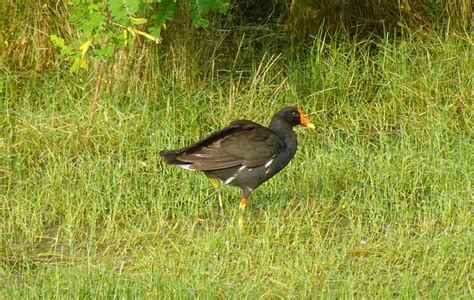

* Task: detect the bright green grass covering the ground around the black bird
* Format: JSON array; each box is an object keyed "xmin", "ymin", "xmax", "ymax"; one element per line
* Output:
[{"xmin": 0, "ymin": 31, "xmax": 474, "ymax": 299}]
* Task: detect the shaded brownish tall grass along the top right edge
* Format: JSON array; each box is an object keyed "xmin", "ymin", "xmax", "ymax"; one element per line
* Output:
[{"xmin": 283, "ymin": 0, "xmax": 472, "ymax": 38}]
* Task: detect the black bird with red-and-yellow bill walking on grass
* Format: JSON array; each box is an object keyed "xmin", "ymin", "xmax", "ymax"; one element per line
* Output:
[{"xmin": 160, "ymin": 106, "xmax": 315, "ymax": 221}]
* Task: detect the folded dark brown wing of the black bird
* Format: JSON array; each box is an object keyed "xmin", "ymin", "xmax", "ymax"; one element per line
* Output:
[{"xmin": 176, "ymin": 120, "xmax": 284, "ymax": 171}]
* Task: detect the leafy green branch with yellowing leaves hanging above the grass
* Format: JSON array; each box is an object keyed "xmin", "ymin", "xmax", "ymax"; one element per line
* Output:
[{"xmin": 50, "ymin": 0, "xmax": 228, "ymax": 73}]
